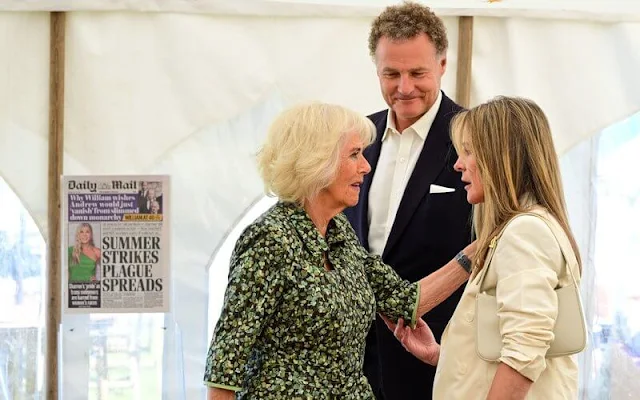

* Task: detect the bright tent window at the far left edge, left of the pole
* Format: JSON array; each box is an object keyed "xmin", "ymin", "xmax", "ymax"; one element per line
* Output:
[{"xmin": 0, "ymin": 178, "xmax": 46, "ymax": 400}]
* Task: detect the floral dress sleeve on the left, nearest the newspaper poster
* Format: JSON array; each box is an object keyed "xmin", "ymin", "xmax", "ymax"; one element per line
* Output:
[{"xmin": 204, "ymin": 220, "xmax": 285, "ymax": 391}]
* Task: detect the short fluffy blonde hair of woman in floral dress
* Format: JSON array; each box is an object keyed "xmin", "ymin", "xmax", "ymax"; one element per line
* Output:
[{"xmin": 258, "ymin": 103, "xmax": 376, "ymax": 205}]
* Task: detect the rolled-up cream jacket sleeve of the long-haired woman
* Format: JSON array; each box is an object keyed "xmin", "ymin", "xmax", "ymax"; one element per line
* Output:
[{"xmin": 491, "ymin": 216, "xmax": 563, "ymax": 382}]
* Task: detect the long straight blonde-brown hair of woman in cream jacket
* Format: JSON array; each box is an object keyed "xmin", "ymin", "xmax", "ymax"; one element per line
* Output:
[{"xmin": 451, "ymin": 96, "xmax": 582, "ymax": 268}]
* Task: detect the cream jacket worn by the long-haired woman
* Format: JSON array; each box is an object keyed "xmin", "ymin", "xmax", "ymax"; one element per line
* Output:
[{"xmin": 433, "ymin": 211, "xmax": 580, "ymax": 400}]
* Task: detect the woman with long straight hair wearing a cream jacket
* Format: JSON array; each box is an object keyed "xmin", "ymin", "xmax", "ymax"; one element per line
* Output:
[{"xmin": 387, "ymin": 97, "xmax": 581, "ymax": 400}]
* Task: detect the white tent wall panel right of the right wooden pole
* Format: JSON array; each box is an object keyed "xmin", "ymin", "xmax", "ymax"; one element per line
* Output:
[{"xmin": 471, "ymin": 18, "xmax": 640, "ymax": 154}]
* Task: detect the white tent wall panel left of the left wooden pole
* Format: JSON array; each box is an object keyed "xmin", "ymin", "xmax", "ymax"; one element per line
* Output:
[{"xmin": 0, "ymin": 12, "xmax": 49, "ymax": 238}]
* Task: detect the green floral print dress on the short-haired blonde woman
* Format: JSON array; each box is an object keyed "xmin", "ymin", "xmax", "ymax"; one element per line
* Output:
[{"xmin": 204, "ymin": 202, "xmax": 419, "ymax": 400}]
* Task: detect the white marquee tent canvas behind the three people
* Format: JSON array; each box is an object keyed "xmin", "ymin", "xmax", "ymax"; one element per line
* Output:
[{"xmin": 0, "ymin": 0, "xmax": 640, "ymax": 399}]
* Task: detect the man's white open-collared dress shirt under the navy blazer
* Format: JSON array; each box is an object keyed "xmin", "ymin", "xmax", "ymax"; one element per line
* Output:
[{"xmin": 367, "ymin": 92, "xmax": 442, "ymax": 255}]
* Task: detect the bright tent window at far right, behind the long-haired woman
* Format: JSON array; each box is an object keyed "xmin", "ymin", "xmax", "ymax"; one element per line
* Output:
[{"xmin": 586, "ymin": 114, "xmax": 640, "ymax": 399}]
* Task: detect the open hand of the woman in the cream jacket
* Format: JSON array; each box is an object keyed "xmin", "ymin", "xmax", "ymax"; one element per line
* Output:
[{"xmin": 381, "ymin": 315, "xmax": 440, "ymax": 365}]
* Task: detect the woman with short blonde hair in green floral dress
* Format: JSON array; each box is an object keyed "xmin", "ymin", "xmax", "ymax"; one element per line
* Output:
[{"xmin": 204, "ymin": 103, "xmax": 472, "ymax": 399}]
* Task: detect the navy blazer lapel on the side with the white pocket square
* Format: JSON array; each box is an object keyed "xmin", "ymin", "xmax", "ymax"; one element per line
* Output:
[{"xmin": 382, "ymin": 95, "xmax": 455, "ymax": 259}]
